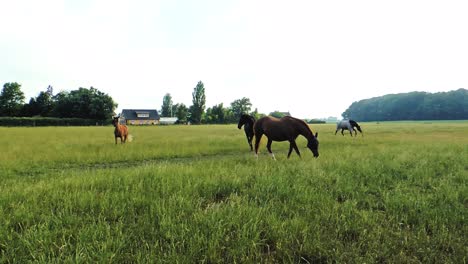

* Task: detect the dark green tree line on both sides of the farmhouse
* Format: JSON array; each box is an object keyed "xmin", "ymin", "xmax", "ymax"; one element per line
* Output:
[{"xmin": 0, "ymin": 81, "xmax": 275, "ymax": 124}]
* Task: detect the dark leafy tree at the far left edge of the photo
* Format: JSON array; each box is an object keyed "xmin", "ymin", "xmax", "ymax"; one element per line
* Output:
[{"xmin": 0, "ymin": 82, "xmax": 25, "ymax": 116}]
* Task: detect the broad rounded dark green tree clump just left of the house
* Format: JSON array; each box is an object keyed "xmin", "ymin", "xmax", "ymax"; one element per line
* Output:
[{"xmin": 54, "ymin": 87, "xmax": 117, "ymax": 120}]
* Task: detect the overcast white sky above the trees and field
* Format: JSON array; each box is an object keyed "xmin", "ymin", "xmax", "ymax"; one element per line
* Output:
[{"xmin": 0, "ymin": 0, "xmax": 468, "ymax": 118}]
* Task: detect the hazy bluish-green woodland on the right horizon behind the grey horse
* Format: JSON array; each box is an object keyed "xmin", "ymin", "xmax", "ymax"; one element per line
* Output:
[{"xmin": 342, "ymin": 89, "xmax": 468, "ymax": 121}]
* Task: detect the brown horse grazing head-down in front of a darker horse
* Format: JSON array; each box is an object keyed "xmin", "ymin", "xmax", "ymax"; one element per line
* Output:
[{"xmin": 254, "ymin": 116, "xmax": 319, "ymax": 159}]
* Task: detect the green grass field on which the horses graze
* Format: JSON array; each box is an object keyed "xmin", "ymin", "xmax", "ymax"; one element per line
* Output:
[{"xmin": 0, "ymin": 122, "xmax": 468, "ymax": 263}]
